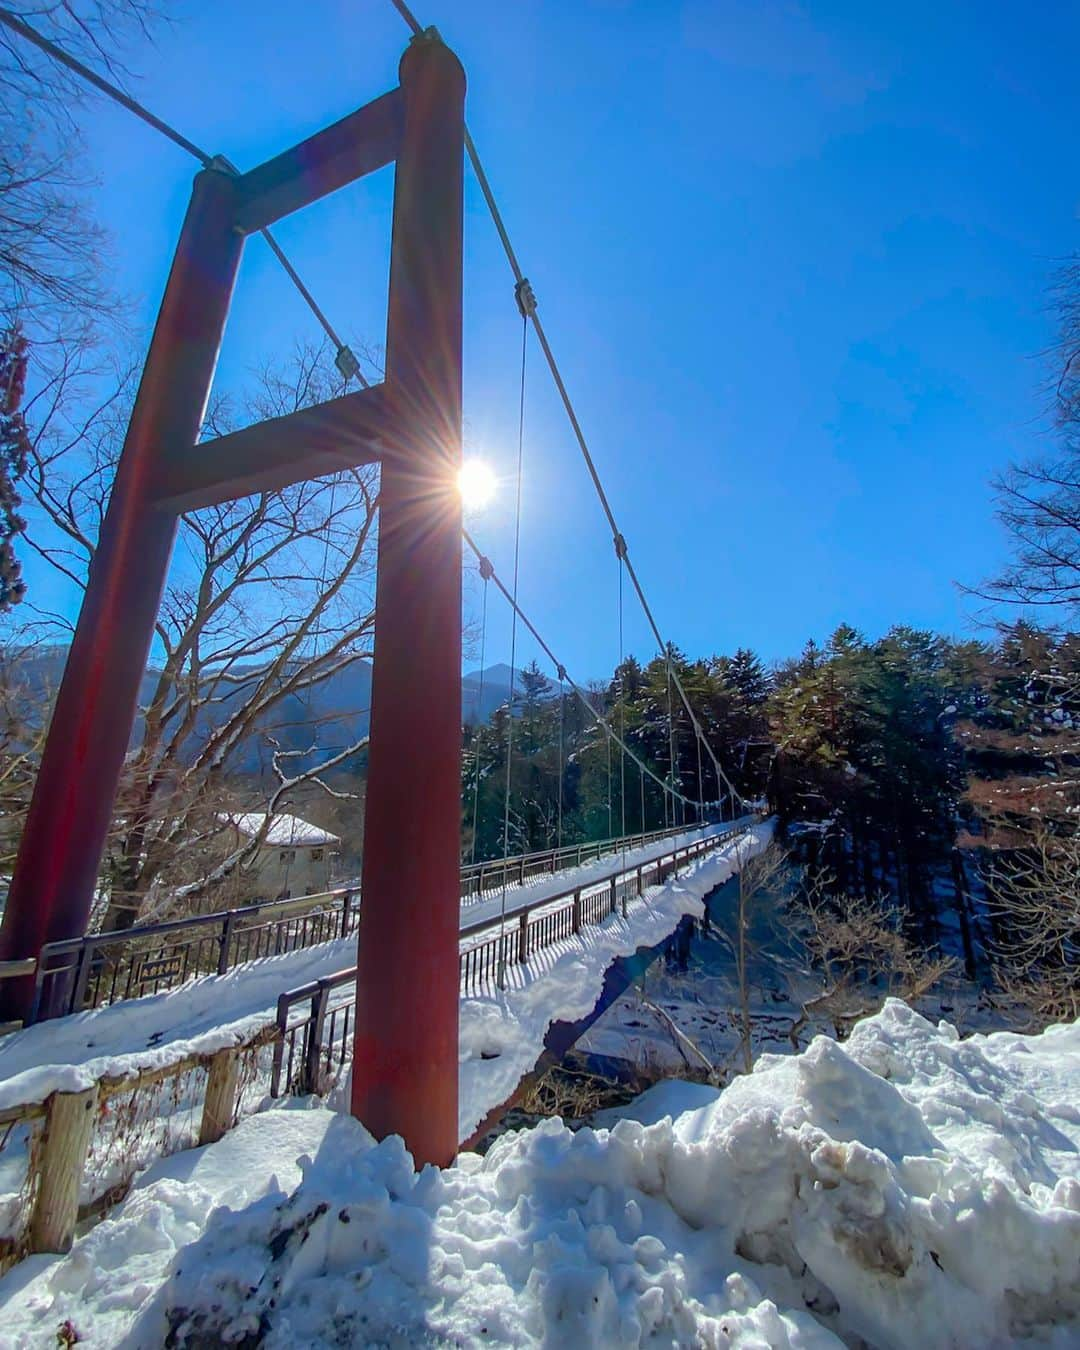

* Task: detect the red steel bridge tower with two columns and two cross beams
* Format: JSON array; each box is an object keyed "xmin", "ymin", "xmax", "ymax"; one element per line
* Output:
[{"xmin": 0, "ymin": 30, "xmax": 464, "ymax": 1164}]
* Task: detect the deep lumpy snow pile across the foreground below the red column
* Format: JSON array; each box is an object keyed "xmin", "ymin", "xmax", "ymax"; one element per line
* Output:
[{"xmin": 0, "ymin": 1002, "xmax": 1080, "ymax": 1347}]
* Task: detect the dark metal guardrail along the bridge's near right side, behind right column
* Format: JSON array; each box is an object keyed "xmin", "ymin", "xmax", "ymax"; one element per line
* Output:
[{"xmin": 270, "ymin": 825, "xmax": 744, "ymax": 1098}]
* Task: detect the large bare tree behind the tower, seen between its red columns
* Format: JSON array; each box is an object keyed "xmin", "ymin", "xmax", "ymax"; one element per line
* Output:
[{"xmin": 15, "ymin": 337, "xmax": 378, "ymax": 927}]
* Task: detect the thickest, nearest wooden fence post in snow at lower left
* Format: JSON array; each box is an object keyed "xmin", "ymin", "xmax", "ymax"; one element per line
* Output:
[{"xmin": 30, "ymin": 1085, "xmax": 97, "ymax": 1253}]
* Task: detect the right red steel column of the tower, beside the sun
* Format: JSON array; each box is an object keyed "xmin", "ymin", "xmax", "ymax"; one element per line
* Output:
[{"xmin": 352, "ymin": 35, "xmax": 464, "ymax": 1165}]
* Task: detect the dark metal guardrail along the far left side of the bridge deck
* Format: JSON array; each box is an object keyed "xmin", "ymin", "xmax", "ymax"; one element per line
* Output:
[{"xmin": 28, "ymin": 826, "xmax": 718, "ymax": 1023}]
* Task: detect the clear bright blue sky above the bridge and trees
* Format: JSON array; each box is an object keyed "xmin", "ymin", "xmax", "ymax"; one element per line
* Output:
[{"xmin": 16, "ymin": 0, "xmax": 1080, "ymax": 678}]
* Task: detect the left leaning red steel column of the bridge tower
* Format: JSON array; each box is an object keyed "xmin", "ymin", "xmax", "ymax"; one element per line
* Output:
[{"xmin": 0, "ymin": 170, "xmax": 243, "ymax": 1017}]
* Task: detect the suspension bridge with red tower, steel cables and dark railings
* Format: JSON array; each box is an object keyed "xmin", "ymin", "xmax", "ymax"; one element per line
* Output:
[{"xmin": 0, "ymin": 0, "xmax": 756, "ymax": 1164}]
